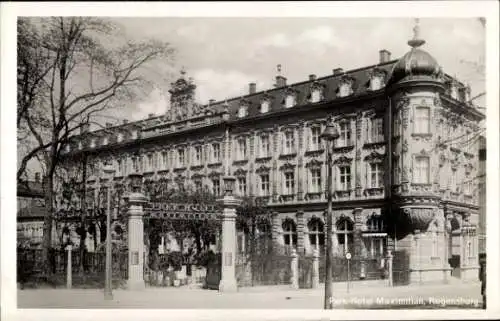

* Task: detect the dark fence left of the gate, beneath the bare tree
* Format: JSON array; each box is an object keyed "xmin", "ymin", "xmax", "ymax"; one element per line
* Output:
[{"xmin": 17, "ymin": 248, "xmax": 128, "ymax": 287}]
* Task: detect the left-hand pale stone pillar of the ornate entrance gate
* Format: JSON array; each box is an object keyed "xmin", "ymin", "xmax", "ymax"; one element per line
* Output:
[{"xmin": 127, "ymin": 192, "xmax": 146, "ymax": 290}]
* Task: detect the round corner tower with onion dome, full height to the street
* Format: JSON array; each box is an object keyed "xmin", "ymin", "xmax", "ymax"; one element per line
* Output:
[{"xmin": 387, "ymin": 19, "xmax": 449, "ymax": 283}]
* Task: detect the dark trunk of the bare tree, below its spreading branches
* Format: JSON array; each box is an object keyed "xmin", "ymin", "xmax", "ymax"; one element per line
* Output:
[{"xmin": 42, "ymin": 175, "xmax": 54, "ymax": 274}]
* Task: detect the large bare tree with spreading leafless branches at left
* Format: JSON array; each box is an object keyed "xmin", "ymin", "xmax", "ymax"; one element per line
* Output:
[{"xmin": 17, "ymin": 17, "xmax": 174, "ymax": 272}]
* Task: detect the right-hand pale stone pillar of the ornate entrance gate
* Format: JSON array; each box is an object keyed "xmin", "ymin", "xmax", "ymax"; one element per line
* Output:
[{"xmin": 219, "ymin": 195, "xmax": 241, "ymax": 292}]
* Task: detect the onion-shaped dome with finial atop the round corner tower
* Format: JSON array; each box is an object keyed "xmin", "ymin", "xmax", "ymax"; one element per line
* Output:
[{"xmin": 388, "ymin": 19, "xmax": 442, "ymax": 85}]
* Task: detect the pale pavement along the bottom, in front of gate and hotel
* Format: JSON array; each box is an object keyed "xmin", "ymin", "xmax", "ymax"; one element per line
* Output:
[{"xmin": 17, "ymin": 282, "xmax": 482, "ymax": 309}]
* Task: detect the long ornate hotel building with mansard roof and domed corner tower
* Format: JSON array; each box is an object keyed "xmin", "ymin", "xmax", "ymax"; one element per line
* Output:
[{"xmin": 58, "ymin": 27, "xmax": 485, "ymax": 280}]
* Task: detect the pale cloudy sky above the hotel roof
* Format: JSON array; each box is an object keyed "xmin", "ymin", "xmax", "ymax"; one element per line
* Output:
[{"xmin": 107, "ymin": 17, "xmax": 485, "ymax": 120}]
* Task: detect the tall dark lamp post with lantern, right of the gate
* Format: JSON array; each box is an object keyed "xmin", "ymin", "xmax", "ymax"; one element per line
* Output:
[{"xmin": 321, "ymin": 118, "xmax": 339, "ymax": 310}]
